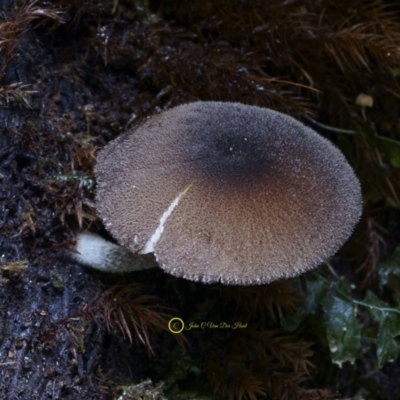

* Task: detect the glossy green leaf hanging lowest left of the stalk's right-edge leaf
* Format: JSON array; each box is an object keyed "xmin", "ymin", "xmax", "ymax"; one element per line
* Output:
[{"xmin": 323, "ymin": 296, "xmax": 360, "ymax": 367}]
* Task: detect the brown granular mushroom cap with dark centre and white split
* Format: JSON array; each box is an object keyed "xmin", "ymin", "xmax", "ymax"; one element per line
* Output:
[{"xmin": 96, "ymin": 102, "xmax": 362, "ymax": 285}]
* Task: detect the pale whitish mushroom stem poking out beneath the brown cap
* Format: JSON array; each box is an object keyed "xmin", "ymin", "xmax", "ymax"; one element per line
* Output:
[{"xmin": 69, "ymin": 232, "xmax": 157, "ymax": 272}]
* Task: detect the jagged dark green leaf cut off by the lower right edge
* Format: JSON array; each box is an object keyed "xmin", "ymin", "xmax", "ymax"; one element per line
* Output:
[{"xmin": 364, "ymin": 291, "xmax": 400, "ymax": 368}]
